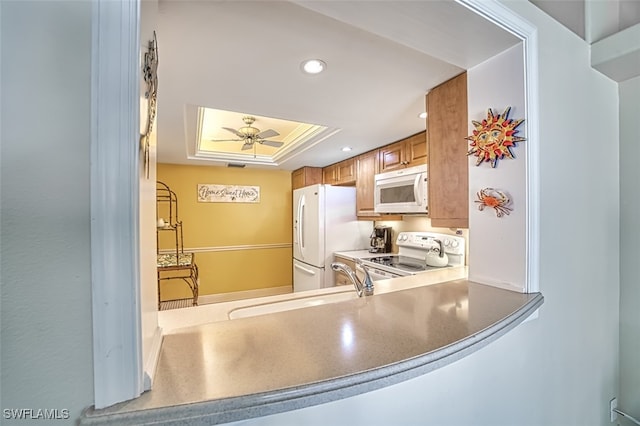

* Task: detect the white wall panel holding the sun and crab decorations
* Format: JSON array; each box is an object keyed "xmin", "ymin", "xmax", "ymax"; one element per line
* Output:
[{"xmin": 467, "ymin": 43, "xmax": 524, "ymax": 291}]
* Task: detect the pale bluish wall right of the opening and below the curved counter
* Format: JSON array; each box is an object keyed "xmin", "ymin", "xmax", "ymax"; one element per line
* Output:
[{"xmin": 225, "ymin": 1, "xmax": 620, "ymax": 426}]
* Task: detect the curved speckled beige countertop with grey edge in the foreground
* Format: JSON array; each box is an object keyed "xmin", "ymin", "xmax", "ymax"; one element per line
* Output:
[{"xmin": 80, "ymin": 271, "xmax": 543, "ymax": 425}]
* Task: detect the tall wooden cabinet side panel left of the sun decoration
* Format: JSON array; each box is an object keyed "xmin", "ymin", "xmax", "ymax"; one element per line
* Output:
[{"xmin": 427, "ymin": 73, "xmax": 469, "ymax": 228}]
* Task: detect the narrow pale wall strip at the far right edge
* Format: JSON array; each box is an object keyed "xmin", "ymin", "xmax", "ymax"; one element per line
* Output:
[{"xmin": 618, "ymin": 77, "xmax": 640, "ymax": 418}]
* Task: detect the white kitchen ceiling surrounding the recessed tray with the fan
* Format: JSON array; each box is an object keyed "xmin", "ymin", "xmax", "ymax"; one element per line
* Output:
[{"xmin": 157, "ymin": 0, "xmax": 519, "ymax": 170}]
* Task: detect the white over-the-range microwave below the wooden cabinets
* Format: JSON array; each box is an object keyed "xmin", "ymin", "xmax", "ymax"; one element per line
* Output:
[{"xmin": 373, "ymin": 164, "xmax": 427, "ymax": 214}]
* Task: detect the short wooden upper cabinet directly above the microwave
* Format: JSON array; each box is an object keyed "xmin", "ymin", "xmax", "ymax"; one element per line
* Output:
[{"xmin": 379, "ymin": 132, "xmax": 428, "ymax": 173}]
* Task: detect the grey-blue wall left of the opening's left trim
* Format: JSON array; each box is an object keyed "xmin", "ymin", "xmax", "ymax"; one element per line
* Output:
[{"xmin": 0, "ymin": 0, "xmax": 93, "ymax": 425}]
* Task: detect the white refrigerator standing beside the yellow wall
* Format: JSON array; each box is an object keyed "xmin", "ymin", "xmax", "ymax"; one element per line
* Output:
[{"xmin": 293, "ymin": 185, "xmax": 371, "ymax": 292}]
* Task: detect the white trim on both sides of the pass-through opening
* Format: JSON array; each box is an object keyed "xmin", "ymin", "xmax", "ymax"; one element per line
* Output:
[{"xmin": 91, "ymin": 0, "xmax": 539, "ymax": 409}]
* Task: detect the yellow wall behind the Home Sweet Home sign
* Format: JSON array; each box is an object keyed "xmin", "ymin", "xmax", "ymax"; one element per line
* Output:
[{"xmin": 157, "ymin": 164, "xmax": 293, "ymax": 300}]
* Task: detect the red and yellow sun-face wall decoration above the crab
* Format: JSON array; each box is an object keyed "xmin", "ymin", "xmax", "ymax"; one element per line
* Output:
[{"xmin": 465, "ymin": 107, "xmax": 526, "ymax": 167}]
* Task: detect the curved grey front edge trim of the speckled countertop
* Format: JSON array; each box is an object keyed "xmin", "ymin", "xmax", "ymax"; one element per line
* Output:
[{"xmin": 80, "ymin": 293, "xmax": 544, "ymax": 425}]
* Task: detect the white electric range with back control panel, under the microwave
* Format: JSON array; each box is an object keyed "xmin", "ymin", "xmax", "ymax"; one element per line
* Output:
[{"xmin": 360, "ymin": 232, "xmax": 465, "ymax": 281}]
